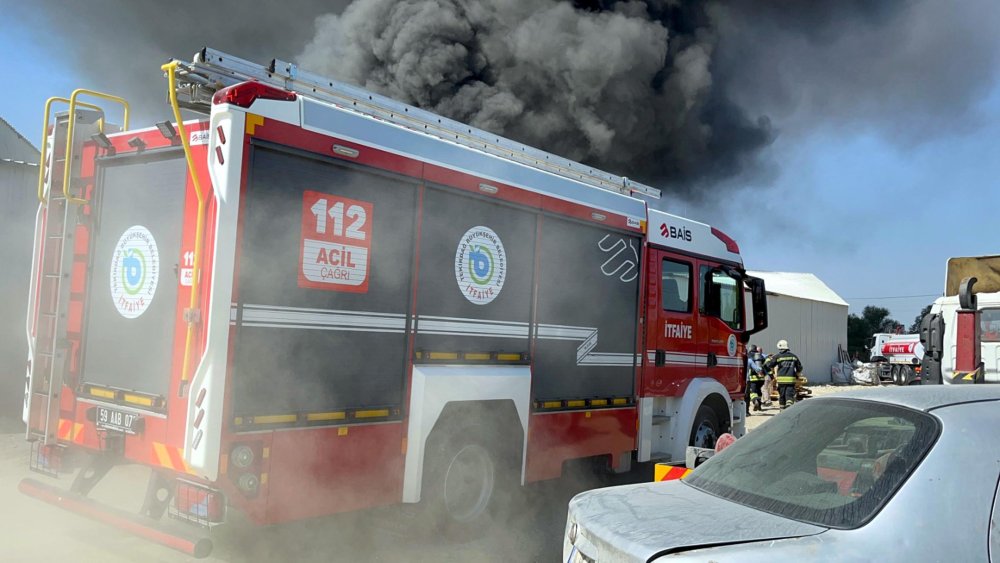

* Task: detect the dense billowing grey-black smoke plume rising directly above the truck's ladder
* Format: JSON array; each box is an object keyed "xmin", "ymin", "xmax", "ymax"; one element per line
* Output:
[{"xmin": 300, "ymin": 0, "xmax": 772, "ymax": 193}]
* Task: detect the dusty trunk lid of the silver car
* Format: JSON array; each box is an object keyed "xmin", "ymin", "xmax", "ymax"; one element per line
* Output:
[{"xmin": 568, "ymin": 481, "xmax": 826, "ymax": 563}]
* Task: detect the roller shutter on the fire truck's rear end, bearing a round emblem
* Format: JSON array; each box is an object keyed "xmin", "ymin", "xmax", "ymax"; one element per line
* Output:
[{"xmin": 82, "ymin": 151, "xmax": 187, "ymax": 396}]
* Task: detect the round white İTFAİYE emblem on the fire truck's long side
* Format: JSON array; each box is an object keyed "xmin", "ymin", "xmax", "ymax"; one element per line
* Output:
[{"xmin": 455, "ymin": 226, "xmax": 507, "ymax": 305}]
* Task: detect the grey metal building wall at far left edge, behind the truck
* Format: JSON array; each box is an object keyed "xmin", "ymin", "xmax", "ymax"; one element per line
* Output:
[{"xmin": 0, "ymin": 160, "xmax": 38, "ymax": 420}]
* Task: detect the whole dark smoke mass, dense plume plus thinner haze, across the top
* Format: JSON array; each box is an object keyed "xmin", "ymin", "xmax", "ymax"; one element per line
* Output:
[{"xmin": 11, "ymin": 0, "xmax": 1000, "ymax": 199}]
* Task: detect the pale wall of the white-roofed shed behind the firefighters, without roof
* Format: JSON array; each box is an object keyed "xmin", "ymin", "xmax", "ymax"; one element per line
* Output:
[{"xmin": 750, "ymin": 294, "xmax": 847, "ymax": 383}]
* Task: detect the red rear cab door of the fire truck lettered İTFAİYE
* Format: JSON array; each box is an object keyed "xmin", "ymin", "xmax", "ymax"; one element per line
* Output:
[{"xmin": 645, "ymin": 250, "xmax": 706, "ymax": 394}]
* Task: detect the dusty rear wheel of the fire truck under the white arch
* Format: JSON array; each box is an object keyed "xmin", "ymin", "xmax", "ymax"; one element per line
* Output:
[{"xmin": 424, "ymin": 424, "xmax": 520, "ymax": 540}]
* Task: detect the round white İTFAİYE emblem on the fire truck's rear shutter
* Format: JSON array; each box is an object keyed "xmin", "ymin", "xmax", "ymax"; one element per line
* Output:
[{"xmin": 111, "ymin": 225, "xmax": 160, "ymax": 319}]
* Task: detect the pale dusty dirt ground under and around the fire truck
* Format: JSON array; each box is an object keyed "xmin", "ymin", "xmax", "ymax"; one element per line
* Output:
[{"xmin": 0, "ymin": 386, "xmax": 880, "ymax": 563}]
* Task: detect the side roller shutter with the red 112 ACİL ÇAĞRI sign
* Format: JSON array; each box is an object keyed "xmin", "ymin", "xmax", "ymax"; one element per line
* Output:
[{"xmin": 232, "ymin": 145, "xmax": 417, "ymax": 428}]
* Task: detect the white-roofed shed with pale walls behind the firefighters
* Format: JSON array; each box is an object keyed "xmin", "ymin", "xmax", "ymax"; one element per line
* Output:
[{"xmin": 747, "ymin": 271, "xmax": 848, "ymax": 383}]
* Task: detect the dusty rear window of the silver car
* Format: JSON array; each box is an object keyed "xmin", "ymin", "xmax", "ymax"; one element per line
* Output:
[{"xmin": 684, "ymin": 399, "xmax": 939, "ymax": 529}]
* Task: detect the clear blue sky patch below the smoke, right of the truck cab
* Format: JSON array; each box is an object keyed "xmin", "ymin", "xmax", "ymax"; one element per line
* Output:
[{"xmin": 700, "ymin": 85, "xmax": 1000, "ymax": 327}]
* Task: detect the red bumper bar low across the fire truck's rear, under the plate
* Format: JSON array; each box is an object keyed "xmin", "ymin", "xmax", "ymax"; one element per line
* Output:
[{"xmin": 17, "ymin": 479, "xmax": 212, "ymax": 559}]
